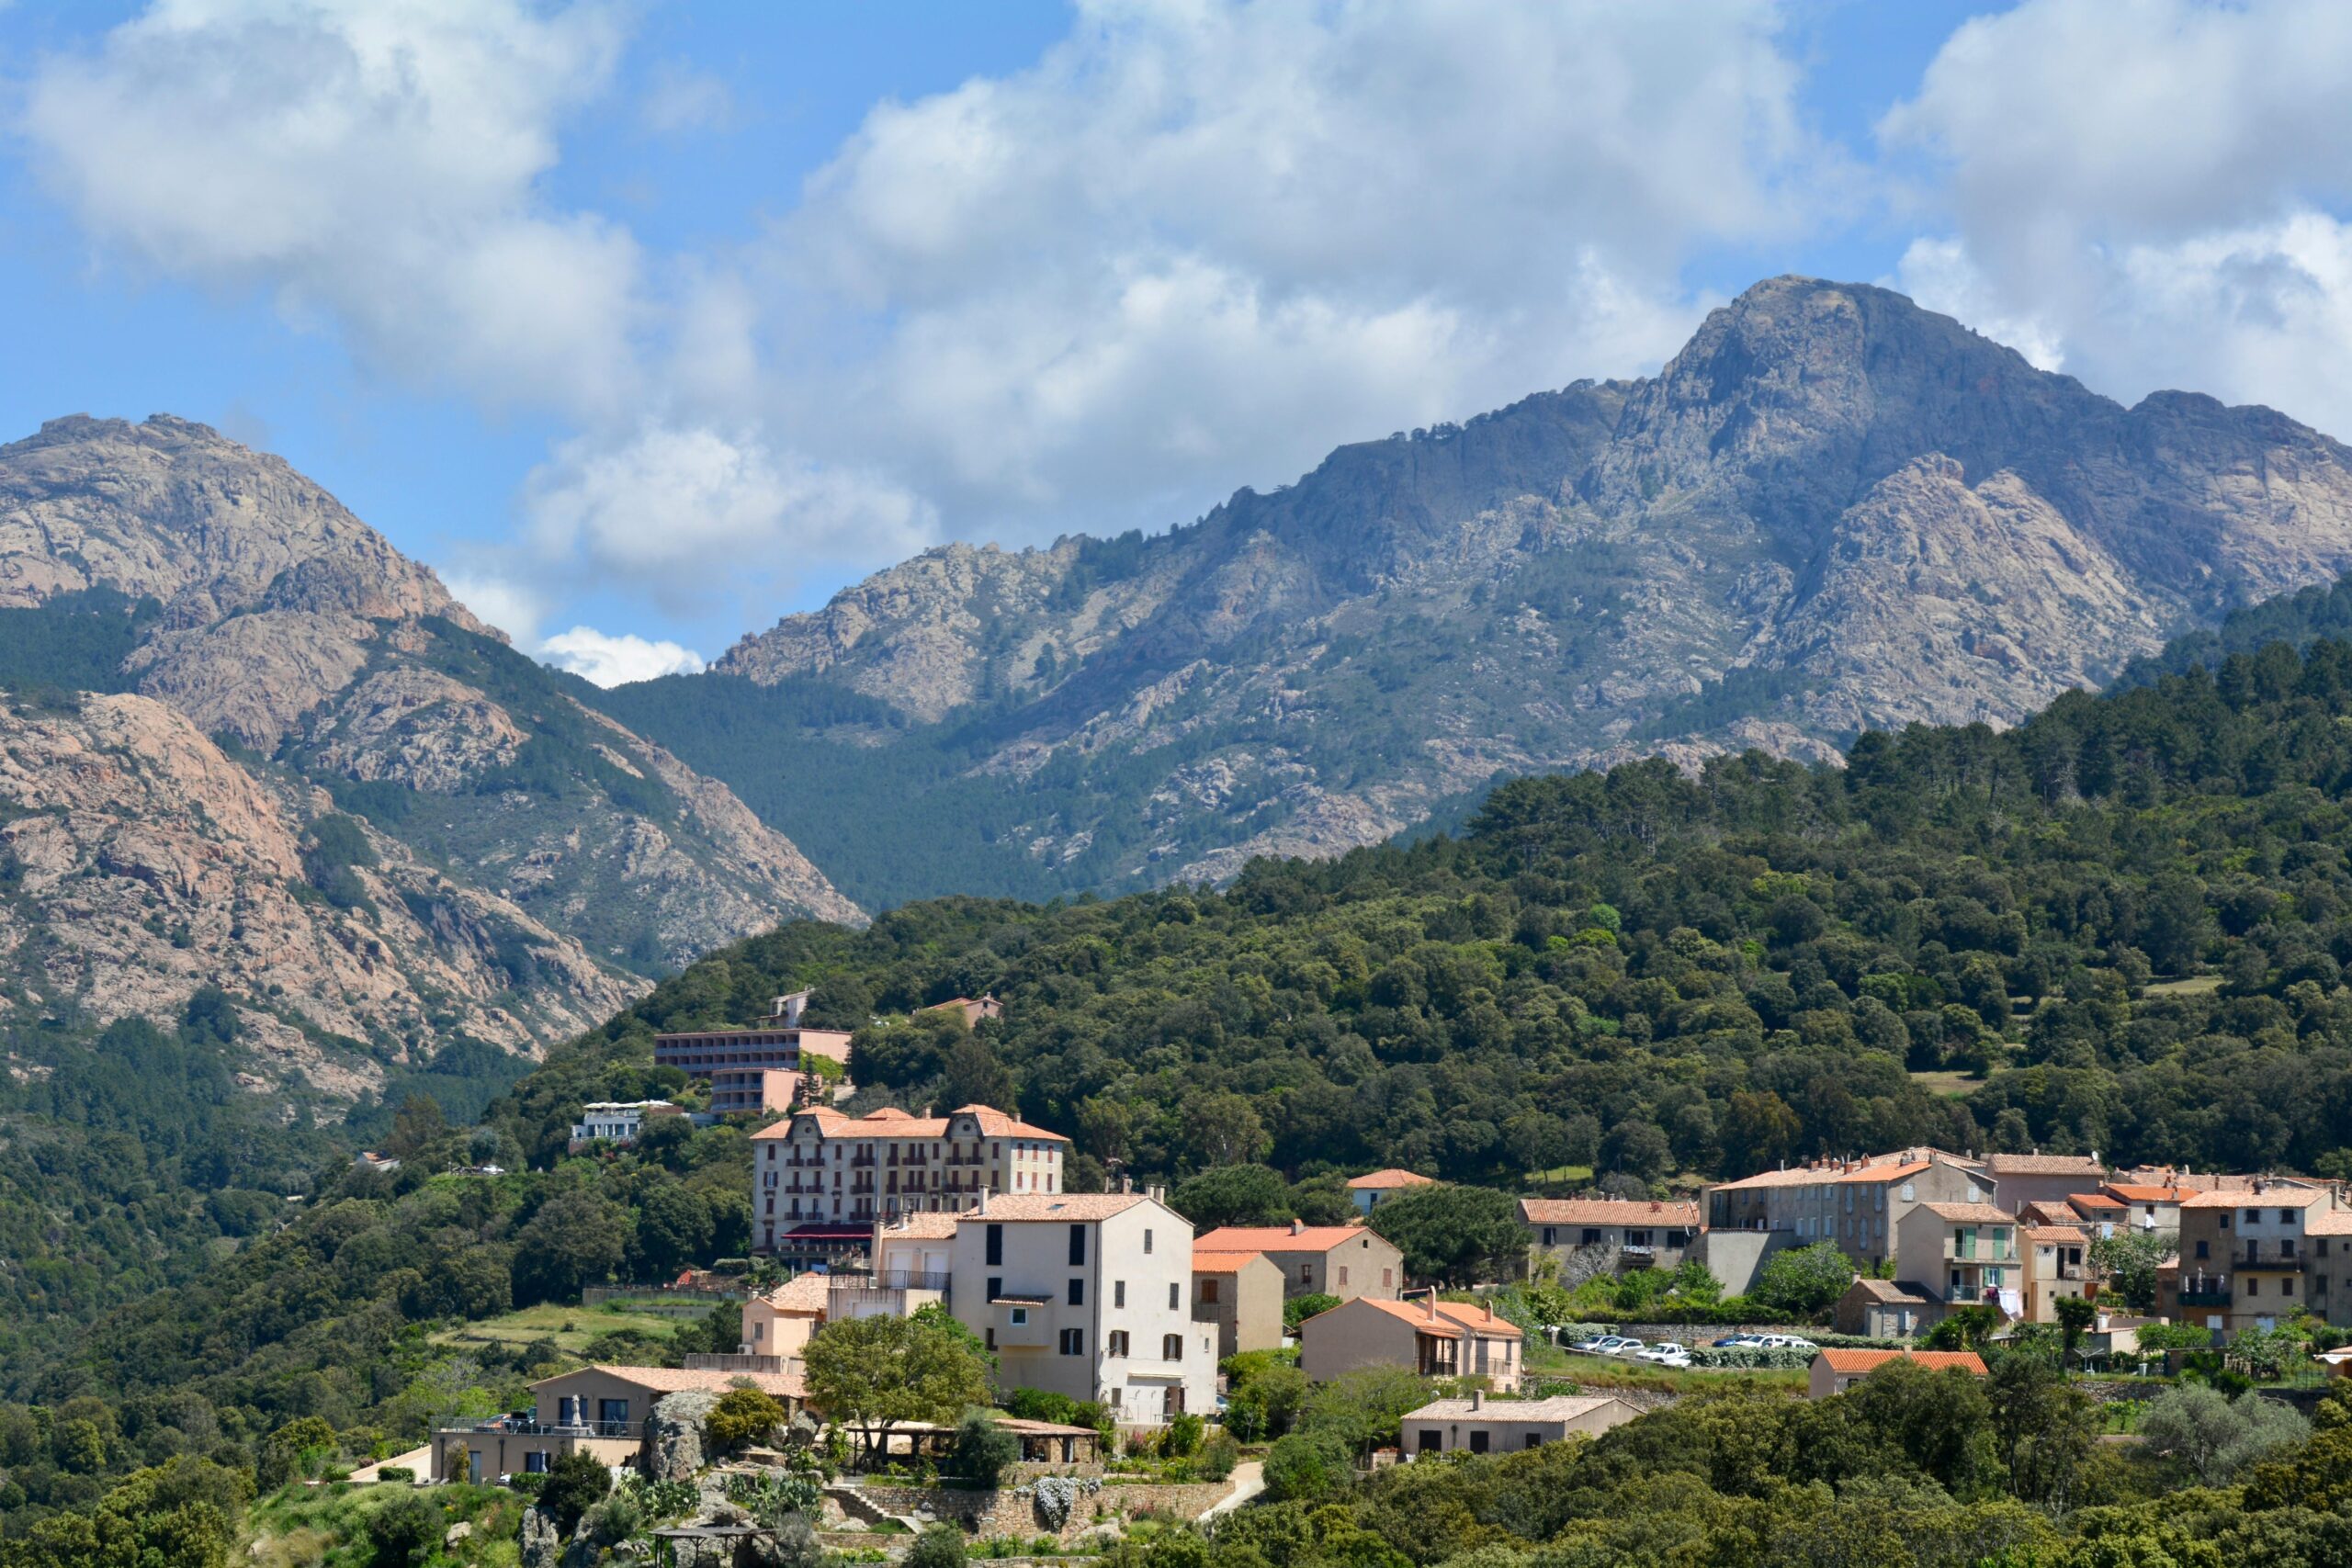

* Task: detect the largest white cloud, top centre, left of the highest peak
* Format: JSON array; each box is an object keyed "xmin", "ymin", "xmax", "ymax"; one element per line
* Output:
[{"xmin": 764, "ymin": 0, "xmax": 1849, "ymax": 534}]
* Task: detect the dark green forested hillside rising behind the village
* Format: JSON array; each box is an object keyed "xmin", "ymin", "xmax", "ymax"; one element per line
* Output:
[{"xmin": 22, "ymin": 642, "xmax": 2352, "ymax": 1561}]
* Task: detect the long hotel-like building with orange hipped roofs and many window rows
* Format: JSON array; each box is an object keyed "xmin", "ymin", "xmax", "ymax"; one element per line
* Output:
[{"xmin": 751, "ymin": 1105, "xmax": 1070, "ymax": 1253}]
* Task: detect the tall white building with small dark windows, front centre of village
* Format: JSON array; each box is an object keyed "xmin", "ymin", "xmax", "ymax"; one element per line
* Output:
[{"xmin": 948, "ymin": 1192, "xmax": 1218, "ymax": 1425}]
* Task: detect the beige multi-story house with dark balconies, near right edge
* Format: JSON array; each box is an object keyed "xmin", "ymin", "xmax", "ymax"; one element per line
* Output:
[{"xmin": 2157, "ymin": 1180, "xmax": 2352, "ymax": 1333}]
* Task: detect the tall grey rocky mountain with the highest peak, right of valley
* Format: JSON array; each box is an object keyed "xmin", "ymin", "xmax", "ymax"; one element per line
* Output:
[{"xmin": 639, "ymin": 277, "xmax": 2352, "ymax": 898}]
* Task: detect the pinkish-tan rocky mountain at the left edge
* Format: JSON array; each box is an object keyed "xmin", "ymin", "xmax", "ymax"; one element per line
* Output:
[{"xmin": 0, "ymin": 416, "xmax": 861, "ymax": 1102}]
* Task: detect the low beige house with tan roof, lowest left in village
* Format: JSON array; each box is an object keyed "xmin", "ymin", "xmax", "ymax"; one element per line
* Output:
[{"xmin": 433, "ymin": 1366, "xmax": 809, "ymax": 1483}]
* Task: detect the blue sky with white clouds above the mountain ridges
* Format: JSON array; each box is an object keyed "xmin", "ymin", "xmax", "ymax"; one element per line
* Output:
[{"xmin": 0, "ymin": 0, "xmax": 2352, "ymax": 680}]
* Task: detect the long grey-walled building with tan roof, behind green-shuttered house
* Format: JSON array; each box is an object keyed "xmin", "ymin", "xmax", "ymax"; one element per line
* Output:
[{"xmin": 1708, "ymin": 1147, "xmax": 1992, "ymax": 1267}]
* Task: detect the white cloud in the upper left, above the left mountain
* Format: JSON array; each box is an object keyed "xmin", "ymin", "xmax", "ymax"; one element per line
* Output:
[{"xmin": 18, "ymin": 0, "xmax": 642, "ymax": 416}]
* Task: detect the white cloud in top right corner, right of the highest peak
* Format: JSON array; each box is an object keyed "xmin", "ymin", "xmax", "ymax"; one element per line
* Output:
[{"xmin": 1879, "ymin": 0, "xmax": 2352, "ymax": 434}]
